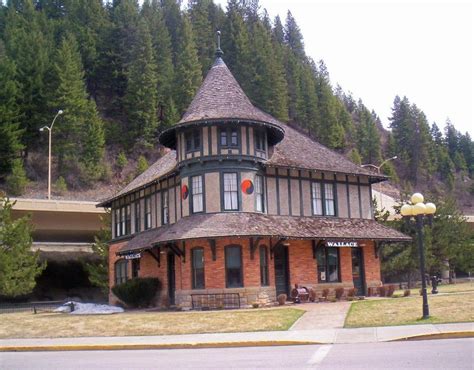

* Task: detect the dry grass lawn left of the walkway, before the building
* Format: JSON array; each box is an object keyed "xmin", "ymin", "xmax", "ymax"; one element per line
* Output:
[{"xmin": 0, "ymin": 308, "xmax": 304, "ymax": 338}]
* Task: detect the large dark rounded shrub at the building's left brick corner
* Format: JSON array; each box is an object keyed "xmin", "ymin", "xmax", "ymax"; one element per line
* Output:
[{"xmin": 112, "ymin": 278, "xmax": 161, "ymax": 307}]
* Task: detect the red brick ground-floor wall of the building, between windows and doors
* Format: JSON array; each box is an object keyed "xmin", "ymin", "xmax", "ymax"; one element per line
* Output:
[{"xmin": 109, "ymin": 237, "xmax": 381, "ymax": 308}]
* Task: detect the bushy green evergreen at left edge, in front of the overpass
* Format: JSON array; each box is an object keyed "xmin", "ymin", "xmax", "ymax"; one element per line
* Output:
[{"xmin": 0, "ymin": 194, "xmax": 46, "ymax": 297}]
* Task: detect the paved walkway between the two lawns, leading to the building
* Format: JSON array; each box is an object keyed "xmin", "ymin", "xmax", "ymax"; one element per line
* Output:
[{"xmin": 290, "ymin": 301, "xmax": 352, "ymax": 330}]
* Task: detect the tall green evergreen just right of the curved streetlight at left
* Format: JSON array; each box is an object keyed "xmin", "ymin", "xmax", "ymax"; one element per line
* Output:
[{"xmin": 51, "ymin": 34, "xmax": 105, "ymax": 185}]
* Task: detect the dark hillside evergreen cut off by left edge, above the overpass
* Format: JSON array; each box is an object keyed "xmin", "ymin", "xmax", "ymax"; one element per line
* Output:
[{"xmin": 0, "ymin": 54, "xmax": 24, "ymax": 177}]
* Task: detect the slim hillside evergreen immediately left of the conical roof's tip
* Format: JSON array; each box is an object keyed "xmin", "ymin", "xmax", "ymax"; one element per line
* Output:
[{"xmin": 176, "ymin": 17, "xmax": 202, "ymax": 113}]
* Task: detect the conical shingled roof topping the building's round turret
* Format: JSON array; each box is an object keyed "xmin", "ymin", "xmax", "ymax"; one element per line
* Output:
[{"xmin": 160, "ymin": 56, "xmax": 284, "ymax": 148}]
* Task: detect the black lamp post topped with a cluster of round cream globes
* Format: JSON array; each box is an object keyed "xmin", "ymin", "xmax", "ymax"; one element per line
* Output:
[{"xmin": 400, "ymin": 193, "xmax": 436, "ymax": 319}]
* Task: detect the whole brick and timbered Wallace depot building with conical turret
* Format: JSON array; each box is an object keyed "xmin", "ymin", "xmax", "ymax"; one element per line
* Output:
[{"xmin": 101, "ymin": 52, "xmax": 410, "ymax": 308}]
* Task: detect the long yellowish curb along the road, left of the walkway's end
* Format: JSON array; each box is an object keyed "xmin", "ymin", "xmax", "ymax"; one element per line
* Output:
[{"xmin": 0, "ymin": 340, "xmax": 325, "ymax": 353}]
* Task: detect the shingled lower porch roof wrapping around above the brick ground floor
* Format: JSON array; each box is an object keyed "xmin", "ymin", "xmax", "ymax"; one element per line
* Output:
[{"xmin": 118, "ymin": 212, "xmax": 411, "ymax": 254}]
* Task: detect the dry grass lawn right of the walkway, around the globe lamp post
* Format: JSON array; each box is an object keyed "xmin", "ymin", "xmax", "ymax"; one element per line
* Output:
[{"xmin": 344, "ymin": 292, "xmax": 474, "ymax": 328}]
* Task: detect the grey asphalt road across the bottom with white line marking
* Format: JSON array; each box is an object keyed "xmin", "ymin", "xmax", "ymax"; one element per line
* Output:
[{"xmin": 0, "ymin": 339, "xmax": 474, "ymax": 370}]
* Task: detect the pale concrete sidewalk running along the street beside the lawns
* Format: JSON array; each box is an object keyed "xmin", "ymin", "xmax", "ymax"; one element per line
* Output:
[{"xmin": 0, "ymin": 323, "xmax": 474, "ymax": 352}]
